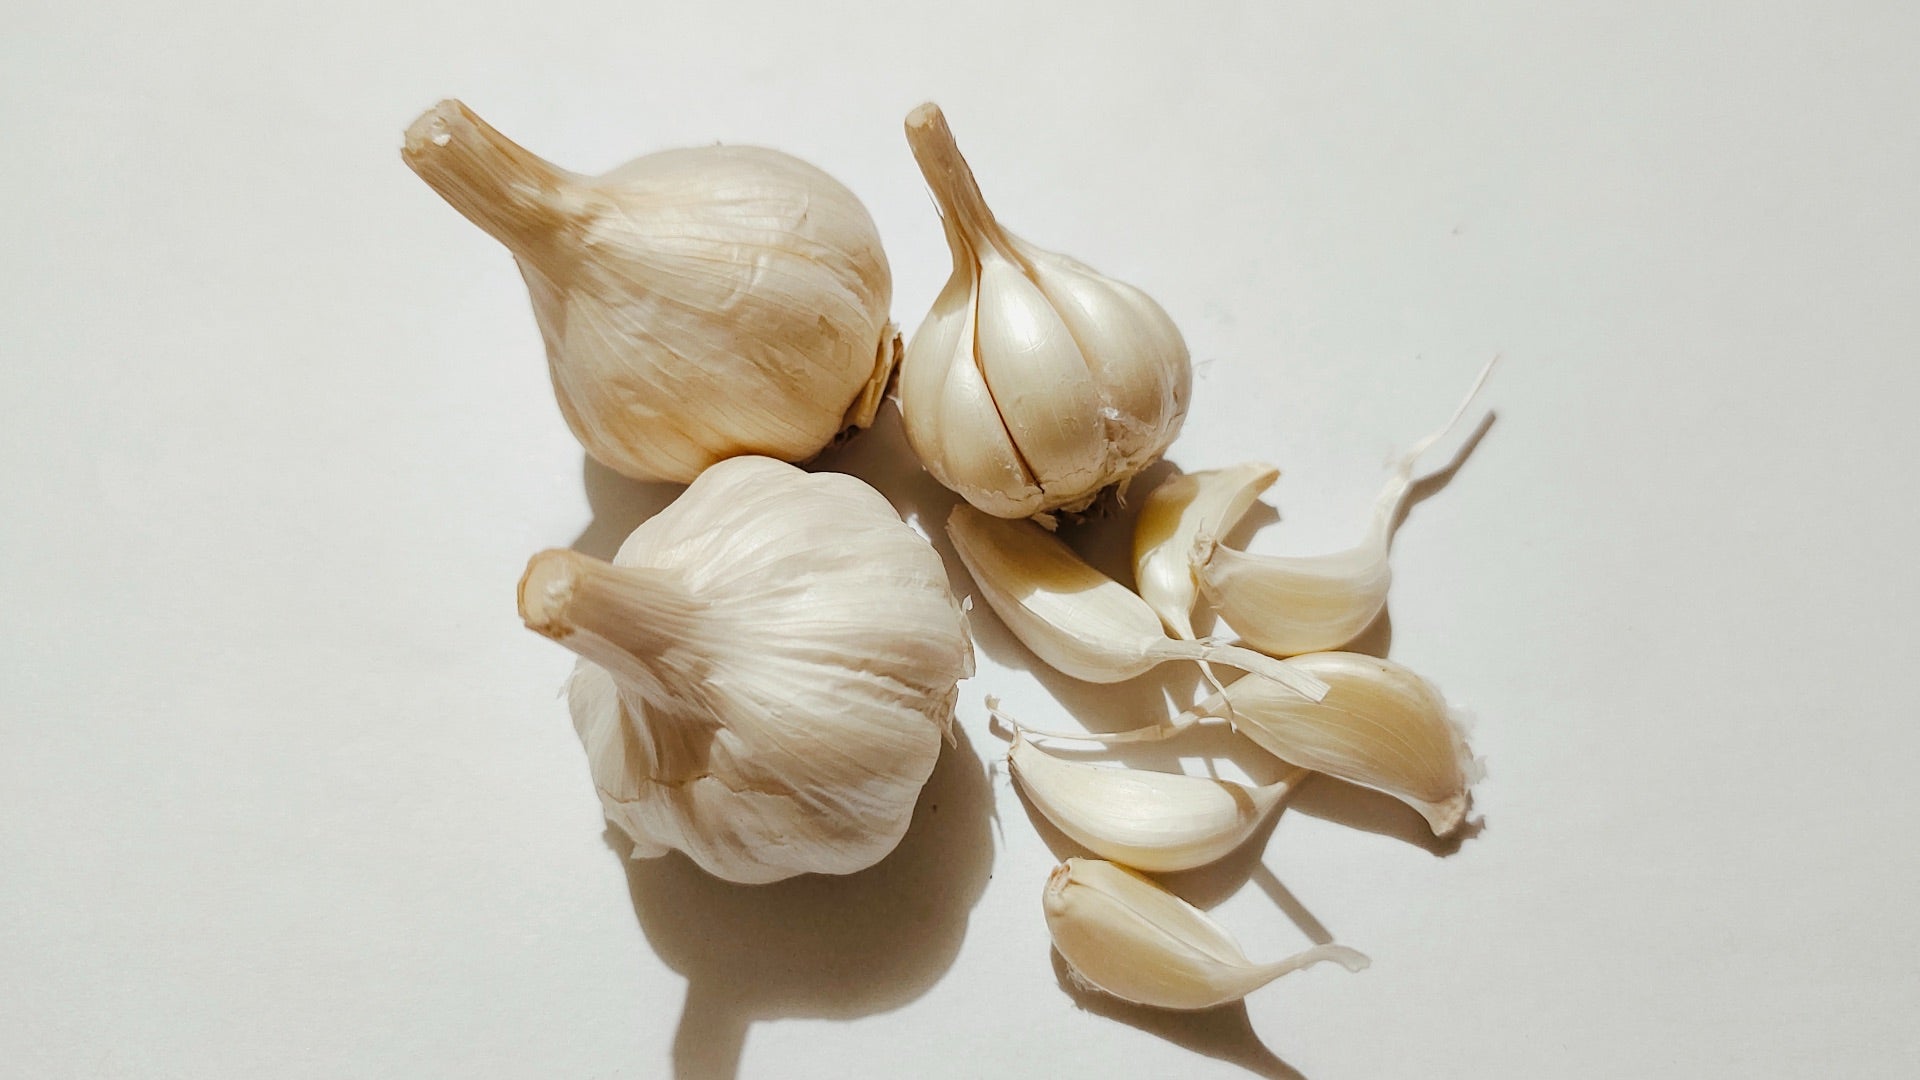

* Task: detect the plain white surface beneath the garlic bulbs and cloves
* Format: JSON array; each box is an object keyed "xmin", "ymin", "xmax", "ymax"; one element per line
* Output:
[{"xmin": 0, "ymin": 2, "xmax": 1920, "ymax": 1080}]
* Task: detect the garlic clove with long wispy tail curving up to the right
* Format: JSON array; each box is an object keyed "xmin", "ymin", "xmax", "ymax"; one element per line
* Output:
[{"xmin": 1190, "ymin": 363, "xmax": 1494, "ymax": 655}]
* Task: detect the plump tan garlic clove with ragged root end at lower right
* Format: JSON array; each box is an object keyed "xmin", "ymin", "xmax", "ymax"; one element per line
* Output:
[{"xmin": 1192, "ymin": 653, "xmax": 1482, "ymax": 836}]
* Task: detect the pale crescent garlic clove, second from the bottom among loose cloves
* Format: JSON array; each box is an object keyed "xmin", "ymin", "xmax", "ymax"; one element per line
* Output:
[{"xmin": 1006, "ymin": 732, "xmax": 1308, "ymax": 874}]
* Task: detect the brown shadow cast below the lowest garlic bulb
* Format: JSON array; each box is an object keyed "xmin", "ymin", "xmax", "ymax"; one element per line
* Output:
[{"xmin": 607, "ymin": 726, "xmax": 993, "ymax": 1080}]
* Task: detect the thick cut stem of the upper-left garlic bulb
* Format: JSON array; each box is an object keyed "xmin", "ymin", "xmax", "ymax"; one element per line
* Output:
[{"xmin": 399, "ymin": 100, "xmax": 580, "ymax": 277}]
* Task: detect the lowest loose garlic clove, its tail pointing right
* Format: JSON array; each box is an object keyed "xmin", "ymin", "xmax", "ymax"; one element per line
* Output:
[{"xmin": 1043, "ymin": 859, "xmax": 1369, "ymax": 1011}]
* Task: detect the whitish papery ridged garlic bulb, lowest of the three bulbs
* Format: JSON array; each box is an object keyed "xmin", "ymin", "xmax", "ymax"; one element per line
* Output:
[{"xmin": 520, "ymin": 457, "xmax": 973, "ymax": 884}]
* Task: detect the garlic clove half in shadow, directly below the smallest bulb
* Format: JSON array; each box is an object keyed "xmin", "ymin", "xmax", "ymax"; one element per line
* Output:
[{"xmin": 947, "ymin": 503, "xmax": 1323, "ymax": 700}]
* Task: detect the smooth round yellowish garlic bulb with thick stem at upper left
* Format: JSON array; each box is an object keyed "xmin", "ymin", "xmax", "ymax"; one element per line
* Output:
[{"xmin": 401, "ymin": 102, "xmax": 899, "ymax": 484}]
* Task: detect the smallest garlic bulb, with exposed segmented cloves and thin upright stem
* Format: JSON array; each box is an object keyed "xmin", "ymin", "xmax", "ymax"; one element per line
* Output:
[{"xmin": 899, "ymin": 104, "xmax": 1192, "ymax": 517}]
